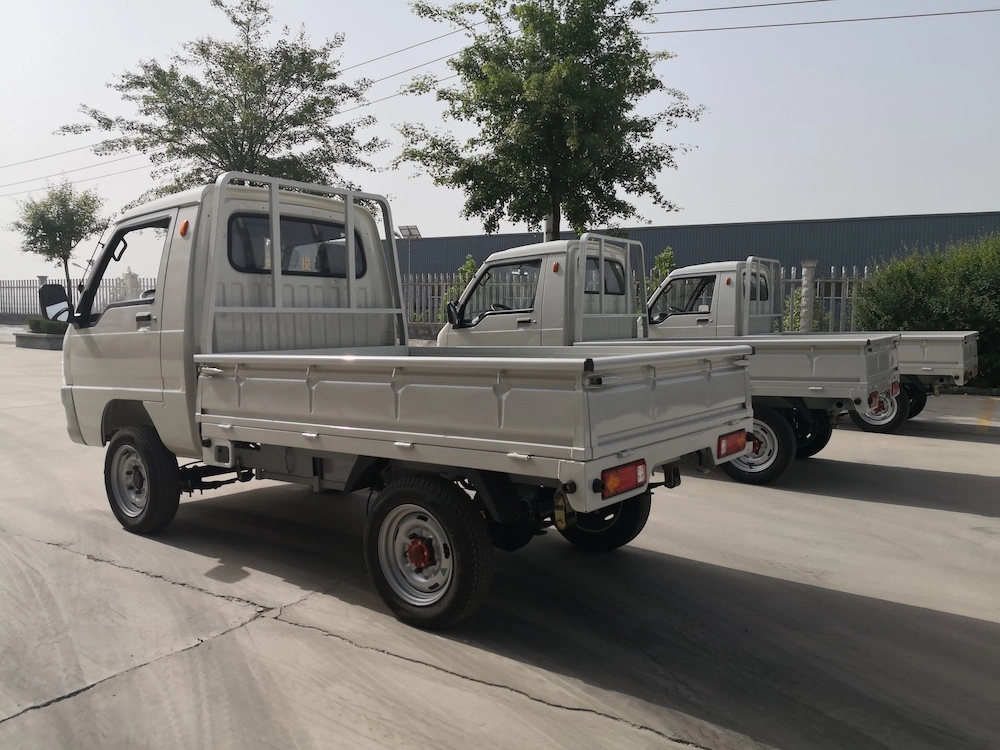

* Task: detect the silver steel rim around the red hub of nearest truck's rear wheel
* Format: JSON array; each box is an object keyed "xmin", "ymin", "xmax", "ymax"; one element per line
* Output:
[{"xmin": 378, "ymin": 504, "xmax": 455, "ymax": 607}]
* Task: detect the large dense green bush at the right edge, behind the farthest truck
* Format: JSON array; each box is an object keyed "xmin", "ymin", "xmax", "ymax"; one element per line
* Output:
[{"xmin": 855, "ymin": 234, "xmax": 1000, "ymax": 387}]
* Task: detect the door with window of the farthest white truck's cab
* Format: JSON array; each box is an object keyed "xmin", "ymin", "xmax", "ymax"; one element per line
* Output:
[{"xmin": 649, "ymin": 274, "xmax": 719, "ymax": 339}]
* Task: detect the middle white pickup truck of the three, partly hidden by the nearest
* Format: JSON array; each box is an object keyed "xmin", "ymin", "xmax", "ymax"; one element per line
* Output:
[{"xmin": 437, "ymin": 234, "xmax": 899, "ymax": 484}]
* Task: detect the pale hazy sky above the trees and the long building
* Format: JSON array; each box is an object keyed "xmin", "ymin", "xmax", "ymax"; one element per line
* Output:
[{"xmin": 0, "ymin": 0, "xmax": 1000, "ymax": 279}]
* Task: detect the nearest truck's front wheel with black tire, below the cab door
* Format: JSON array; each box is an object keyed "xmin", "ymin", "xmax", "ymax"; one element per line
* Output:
[{"xmin": 104, "ymin": 427, "xmax": 181, "ymax": 534}]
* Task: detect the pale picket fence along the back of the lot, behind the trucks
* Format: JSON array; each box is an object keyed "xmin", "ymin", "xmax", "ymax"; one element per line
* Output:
[{"xmin": 0, "ymin": 267, "xmax": 868, "ymax": 331}]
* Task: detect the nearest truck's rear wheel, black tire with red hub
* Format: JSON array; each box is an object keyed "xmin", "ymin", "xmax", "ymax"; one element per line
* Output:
[{"xmin": 364, "ymin": 475, "xmax": 493, "ymax": 630}]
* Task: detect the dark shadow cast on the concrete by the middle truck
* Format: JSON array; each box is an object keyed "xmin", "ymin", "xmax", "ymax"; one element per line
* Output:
[{"xmin": 705, "ymin": 462, "xmax": 1000, "ymax": 518}]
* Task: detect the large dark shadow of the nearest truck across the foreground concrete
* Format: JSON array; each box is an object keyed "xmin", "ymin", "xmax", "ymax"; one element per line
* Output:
[{"xmin": 158, "ymin": 487, "xmax": 1000, "ymax": 750}]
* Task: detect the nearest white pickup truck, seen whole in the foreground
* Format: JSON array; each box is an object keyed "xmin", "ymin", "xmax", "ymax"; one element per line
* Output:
[{"xmin": 40, "ymin": 173, "xmax": 752, "ymax": 628}]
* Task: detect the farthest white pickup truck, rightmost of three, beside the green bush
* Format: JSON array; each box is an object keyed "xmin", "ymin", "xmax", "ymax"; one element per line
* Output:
[{"xmin": 648, "ymin": 257, "xmax": 979, "ymax": 432}]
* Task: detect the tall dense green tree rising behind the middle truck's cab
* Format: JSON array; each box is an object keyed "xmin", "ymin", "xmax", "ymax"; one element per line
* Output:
[{"xmin": 395, "ymin": 0, "xmax": 702, "ymax": 238}]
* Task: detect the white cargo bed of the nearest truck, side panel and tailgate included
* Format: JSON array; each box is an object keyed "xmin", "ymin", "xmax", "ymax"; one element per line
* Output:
[{"xmin": 195, "ymin": 346, "xmax": 751, "ymax": 510}]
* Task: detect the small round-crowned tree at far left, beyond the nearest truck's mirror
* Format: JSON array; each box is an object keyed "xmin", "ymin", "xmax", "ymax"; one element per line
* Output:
[{"xmin": 10, "ymin": 180, "xmax": 108, "ymax": 300}]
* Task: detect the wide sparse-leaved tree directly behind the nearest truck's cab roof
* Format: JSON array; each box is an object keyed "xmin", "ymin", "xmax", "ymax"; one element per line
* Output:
[{"xmin": 61, "ymin": 0, "xmax": 385, "ymax": 203}]
